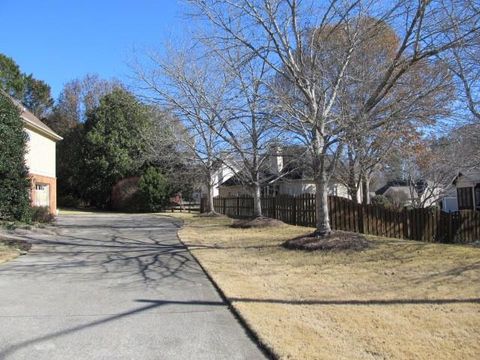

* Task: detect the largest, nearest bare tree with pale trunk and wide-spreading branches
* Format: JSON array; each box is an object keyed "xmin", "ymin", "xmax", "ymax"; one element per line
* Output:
[{"xmin": 190, "ymin": 0, "xmax": 478, "ymax": 236}]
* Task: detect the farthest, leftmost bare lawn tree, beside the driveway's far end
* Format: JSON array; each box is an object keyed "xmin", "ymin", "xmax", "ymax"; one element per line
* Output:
[{"xmin": 134, "ymin": 48, "xmax": 228, "ymax": 213}]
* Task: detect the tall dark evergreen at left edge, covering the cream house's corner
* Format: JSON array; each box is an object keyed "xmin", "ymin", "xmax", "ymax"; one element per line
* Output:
[{"xmin": 0, "ymin": 91, "xmax": 30, "ymax": 221}]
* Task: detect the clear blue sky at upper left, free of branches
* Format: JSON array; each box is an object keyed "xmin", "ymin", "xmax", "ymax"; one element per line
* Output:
[{"xmin": 0, "ymin": 0, "xmax": 182, "ymax": 98}]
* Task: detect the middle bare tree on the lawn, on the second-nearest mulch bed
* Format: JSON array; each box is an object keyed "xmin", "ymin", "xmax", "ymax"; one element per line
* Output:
[{"xmin": 205, "ymin": 46, "xmax": 282, "ymax": 217}]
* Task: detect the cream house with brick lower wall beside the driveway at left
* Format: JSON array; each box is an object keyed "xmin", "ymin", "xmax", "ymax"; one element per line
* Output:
[{"xmin": 15, "ymin": 101, "xmax": 62, "ymax": 214}]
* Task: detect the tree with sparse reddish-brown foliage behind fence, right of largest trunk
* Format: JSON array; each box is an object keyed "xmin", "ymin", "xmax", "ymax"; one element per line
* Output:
[{"xmin": 337, "ymin": 53, "xmax": 454, "ymax": 204}]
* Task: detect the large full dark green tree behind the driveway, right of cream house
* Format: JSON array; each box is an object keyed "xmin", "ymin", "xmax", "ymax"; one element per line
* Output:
[{"xmin": 79, "ymin": 89, "xmax": 151, "ymax": 208}]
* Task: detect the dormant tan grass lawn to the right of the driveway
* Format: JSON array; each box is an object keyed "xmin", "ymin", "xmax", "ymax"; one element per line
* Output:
[{"xmin": 168, "ymin": 214, "xmax": 480, "ymax": 359}]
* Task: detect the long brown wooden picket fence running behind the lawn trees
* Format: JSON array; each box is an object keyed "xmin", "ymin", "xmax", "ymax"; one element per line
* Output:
[{"xmin": 201, "ymin": 194, "xmax": 480, "ymax": 243}]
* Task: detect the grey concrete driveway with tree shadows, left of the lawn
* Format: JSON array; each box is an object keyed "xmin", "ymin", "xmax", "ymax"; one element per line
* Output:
[{"xmin": 0, "ymin": 214, "xmax": 264, "ymax": 360}]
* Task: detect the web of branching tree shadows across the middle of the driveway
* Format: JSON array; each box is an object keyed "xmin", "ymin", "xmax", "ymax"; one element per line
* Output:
[{"xmin": 0, "ymin": 219, "xmax": 202, "ymax": 285}]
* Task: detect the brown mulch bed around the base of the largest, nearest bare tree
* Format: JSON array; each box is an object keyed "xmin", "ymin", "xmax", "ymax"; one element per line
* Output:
[{"xmin": 283, "ymin": 231, "xmax": 371, "ymax": 251}]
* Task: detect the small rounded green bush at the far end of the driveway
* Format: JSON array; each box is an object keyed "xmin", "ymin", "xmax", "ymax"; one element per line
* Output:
[{"xmin": 138, "ymin": 167, "xmax": 170, "ymax": 212}]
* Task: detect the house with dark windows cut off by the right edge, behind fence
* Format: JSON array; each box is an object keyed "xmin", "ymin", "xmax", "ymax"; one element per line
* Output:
[{"xmin": 453, "ymin": 170, "xmax": 480, "ymax": 211}]
